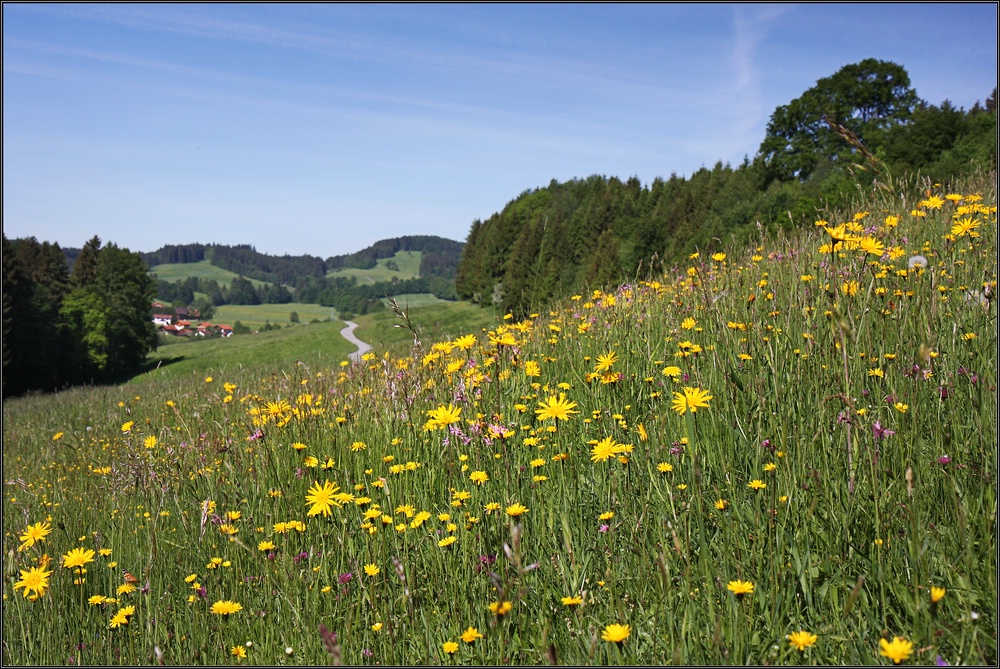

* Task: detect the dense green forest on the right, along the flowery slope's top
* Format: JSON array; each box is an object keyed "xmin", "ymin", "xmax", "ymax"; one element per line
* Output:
[{"xmin": 456, "ymin": 59, "xmax": 997, "ymax": 316}]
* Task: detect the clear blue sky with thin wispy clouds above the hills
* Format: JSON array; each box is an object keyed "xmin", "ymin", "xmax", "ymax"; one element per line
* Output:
[{"xmin": 3, "ymin": 3, "xmax": 997, "ymax": 258}]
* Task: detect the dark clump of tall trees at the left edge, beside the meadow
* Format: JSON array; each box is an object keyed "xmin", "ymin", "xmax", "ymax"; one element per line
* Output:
[{"xmin": 3, "ymin": 235, "xmax": 157, "ymax": 397}]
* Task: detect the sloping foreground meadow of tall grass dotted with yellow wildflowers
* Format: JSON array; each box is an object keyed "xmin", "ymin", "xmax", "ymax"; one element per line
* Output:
[{"xmin": 2, "ymin": 174, "xmax": 997, "ymax": 665}]
